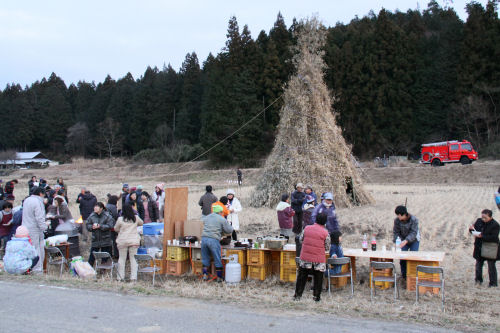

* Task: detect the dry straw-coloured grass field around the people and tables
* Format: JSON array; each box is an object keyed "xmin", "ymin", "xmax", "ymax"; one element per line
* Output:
[{"xmin": 0, "ymin": 160, "xmax": 500, "ymax": 331}]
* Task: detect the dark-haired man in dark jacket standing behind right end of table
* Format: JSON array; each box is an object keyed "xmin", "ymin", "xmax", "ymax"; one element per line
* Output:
[{"xmin": 393, "ymin": 206, "xmax": 420, "ymax": 285}]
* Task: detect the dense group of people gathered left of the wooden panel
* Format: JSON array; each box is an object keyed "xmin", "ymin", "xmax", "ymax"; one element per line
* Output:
[{"xmin": 0, "ymin": 176, "xmax": 165, "ymax": 280}]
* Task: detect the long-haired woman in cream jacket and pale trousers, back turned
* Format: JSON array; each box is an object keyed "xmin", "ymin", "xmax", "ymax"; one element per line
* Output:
[{"xmin": 115, "ymin": 205, "xmax": 142, "ymax": 281}]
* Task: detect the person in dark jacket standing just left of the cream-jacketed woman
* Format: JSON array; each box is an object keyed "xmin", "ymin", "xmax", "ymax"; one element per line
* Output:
[{"xmin": 86, "ymin": 202, "xmax": 115, "ymax": 266}]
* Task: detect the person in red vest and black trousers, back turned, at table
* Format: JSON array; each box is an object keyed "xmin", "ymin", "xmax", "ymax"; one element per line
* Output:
[{"xmin": 294, "ymin": 213, "xmax": 330, "ymax": 302}]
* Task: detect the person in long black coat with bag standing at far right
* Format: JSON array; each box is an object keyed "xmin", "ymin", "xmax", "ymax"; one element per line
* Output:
[{"xmin": 469, "ymin": 209, "xmax": 500, "ymax": 287}]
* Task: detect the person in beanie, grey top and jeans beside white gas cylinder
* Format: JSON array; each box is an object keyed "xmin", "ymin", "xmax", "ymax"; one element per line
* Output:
[{"xmin": 201, "ymin": 205, "xmax": 233, "ymax": 282}]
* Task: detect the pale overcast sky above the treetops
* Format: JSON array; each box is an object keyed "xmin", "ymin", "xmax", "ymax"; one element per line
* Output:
[{"xmin": 0, "ymin": 0, "xmax": 487, "ymax": 89}]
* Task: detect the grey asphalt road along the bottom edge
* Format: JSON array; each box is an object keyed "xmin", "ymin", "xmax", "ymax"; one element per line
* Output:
[{"xmin": 0, "ymin": 281, "xmax": 450, "ymax": 333}]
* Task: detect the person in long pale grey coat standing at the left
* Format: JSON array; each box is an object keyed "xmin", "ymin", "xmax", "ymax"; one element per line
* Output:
[{"xmin": 22, "ymin": 187, "xmax": 47, "ymax": 274}]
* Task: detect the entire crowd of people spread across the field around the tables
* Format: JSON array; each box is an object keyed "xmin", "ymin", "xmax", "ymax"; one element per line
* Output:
[{"xmin": 0, "ymin": 173, "xmax": 500, "ymax": 301}]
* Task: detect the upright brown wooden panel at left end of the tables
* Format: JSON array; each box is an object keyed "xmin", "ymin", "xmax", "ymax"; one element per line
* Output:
[{"xmin": 163, "ymin": 187, "xmax": 188, "ymax": 268}]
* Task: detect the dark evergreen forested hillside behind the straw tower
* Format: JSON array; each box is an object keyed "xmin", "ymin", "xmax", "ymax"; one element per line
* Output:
[{"xmin": 0, "ymin": 0, "xmax": 500, "ymax": 165}]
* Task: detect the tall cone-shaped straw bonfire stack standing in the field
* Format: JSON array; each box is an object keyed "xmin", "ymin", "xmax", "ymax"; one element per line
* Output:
[{"xmin": 251, "ymin": 17, "xmax": 373, "ymax": 207}]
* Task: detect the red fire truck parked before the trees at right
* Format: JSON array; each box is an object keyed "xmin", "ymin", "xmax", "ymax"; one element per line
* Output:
[{"xmin": 420, "ymin": 140, "xmax": 479, "ymax": 166}]
